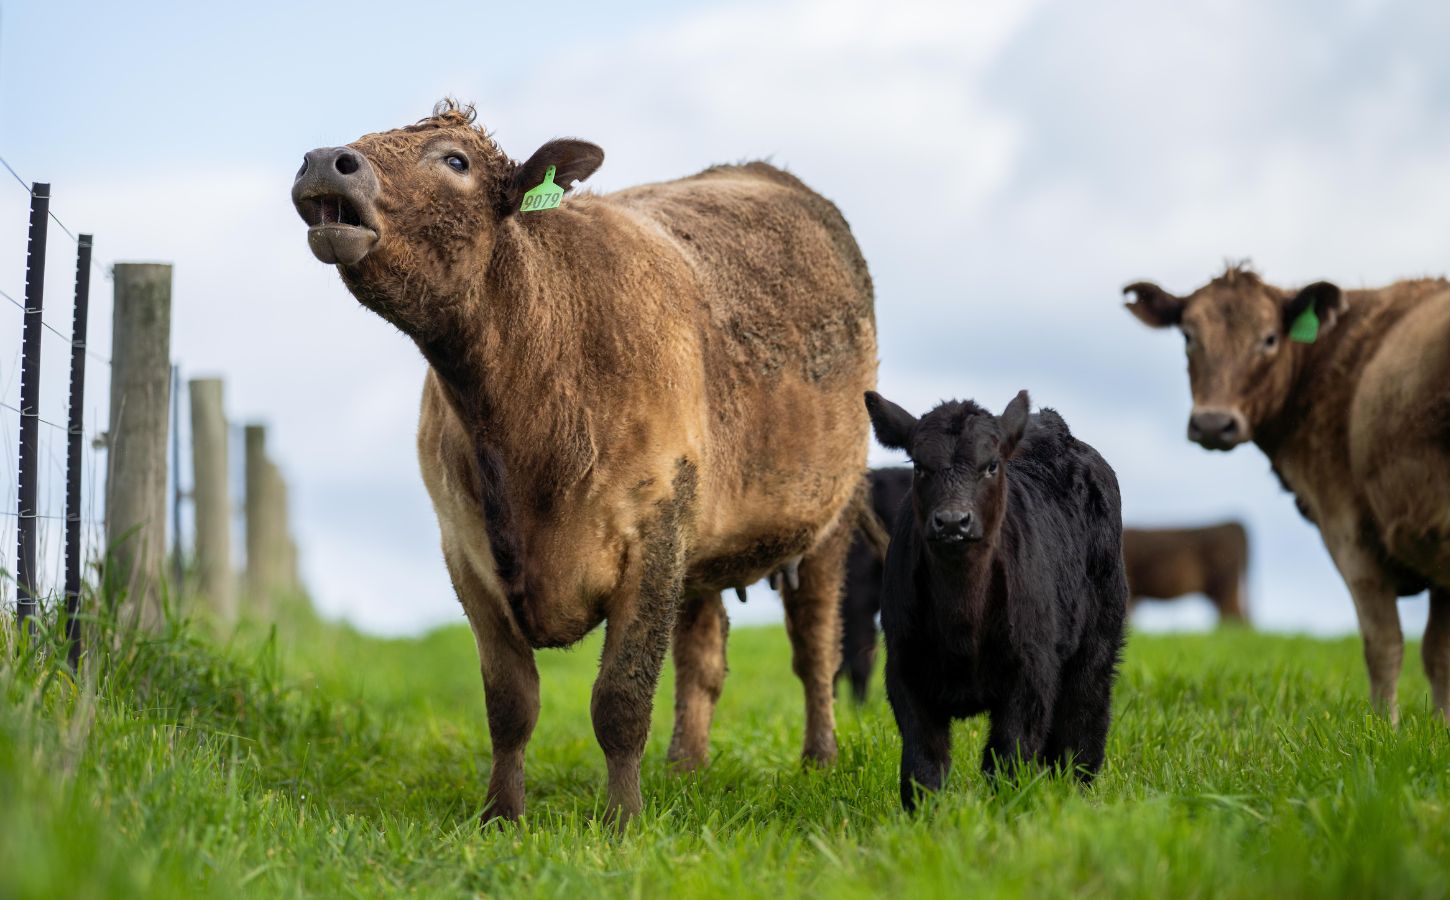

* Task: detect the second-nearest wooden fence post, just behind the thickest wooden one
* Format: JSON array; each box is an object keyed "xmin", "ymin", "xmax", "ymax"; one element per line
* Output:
[{"xmin": 190, "ymin": 378, "xmax": 236, "ymax": 622}]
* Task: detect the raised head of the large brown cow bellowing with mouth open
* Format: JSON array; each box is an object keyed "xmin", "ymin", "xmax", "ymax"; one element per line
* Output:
[{"xmin": 291, "ymin": 101, "xmax": 605, "ymax": 330}]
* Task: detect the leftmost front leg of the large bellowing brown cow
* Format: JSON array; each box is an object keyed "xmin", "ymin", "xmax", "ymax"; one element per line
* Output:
[{"xmin": 444, "ymin": 548, "xmax": 539, "ymax": 822}]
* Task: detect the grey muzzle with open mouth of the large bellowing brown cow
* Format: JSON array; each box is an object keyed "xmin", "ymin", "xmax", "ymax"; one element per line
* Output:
[{"xmin": 291, "ymin": 146, "xmax": 377, "ymax": 265}]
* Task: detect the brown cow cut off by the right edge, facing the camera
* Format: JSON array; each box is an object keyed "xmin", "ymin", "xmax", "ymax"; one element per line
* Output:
[{"xmin": 1124, "ymin": 267, "xmax": 1450, "ymax": 719}]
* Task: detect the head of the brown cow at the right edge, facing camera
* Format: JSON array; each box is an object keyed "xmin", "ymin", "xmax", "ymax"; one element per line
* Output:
[{"xmin": 1124, "ymin": 270, "xmax": 1344, "ymax": 451}]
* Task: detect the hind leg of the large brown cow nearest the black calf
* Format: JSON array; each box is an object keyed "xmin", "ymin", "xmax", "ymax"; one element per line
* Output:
[{"xmin": 782, "ymin": 523, "xmax": 851, "ymax": 765}]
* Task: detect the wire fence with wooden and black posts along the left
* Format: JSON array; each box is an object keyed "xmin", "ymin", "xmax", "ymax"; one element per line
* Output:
[{"xmin": 0, "ymin": 158, "xmax": 300, "ymax": 661}]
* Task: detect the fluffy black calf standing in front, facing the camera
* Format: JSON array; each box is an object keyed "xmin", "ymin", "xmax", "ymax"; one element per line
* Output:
[{"xmin": 866, "ymin": 391, "xmax": 1128, "ymax": 810}]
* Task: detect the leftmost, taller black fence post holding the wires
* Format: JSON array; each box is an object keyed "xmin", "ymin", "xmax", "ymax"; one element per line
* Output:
[{"xmin": 15, "ymin": 181, "xmax": 51, "ymax": 628}]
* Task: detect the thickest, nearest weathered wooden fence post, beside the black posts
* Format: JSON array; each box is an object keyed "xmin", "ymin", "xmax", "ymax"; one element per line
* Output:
[{"xmin": 106, "ymin": 262, "xmax": 171, "ymax": 626}]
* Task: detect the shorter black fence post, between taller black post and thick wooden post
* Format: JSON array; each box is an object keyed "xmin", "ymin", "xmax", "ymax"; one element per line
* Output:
[{"xmin": 65, "ymin": 235, "xmax": 91, "ymax": 670}]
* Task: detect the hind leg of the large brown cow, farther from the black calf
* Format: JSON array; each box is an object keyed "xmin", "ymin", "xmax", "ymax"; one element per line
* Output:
[{"xmin": 670, "ymin": 591, "xmax": 729, "ymax": 770}]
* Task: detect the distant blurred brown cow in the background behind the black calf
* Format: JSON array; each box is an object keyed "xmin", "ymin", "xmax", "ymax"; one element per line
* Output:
[{"xmin": 1122, "ymin": 522, "xmax": 1248, "ymax": 622}]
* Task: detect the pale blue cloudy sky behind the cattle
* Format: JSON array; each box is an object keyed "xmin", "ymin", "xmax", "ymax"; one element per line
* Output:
[{"xmin": 0, "ymin": 0, "xmax": 1450, "ymax": 636}]
